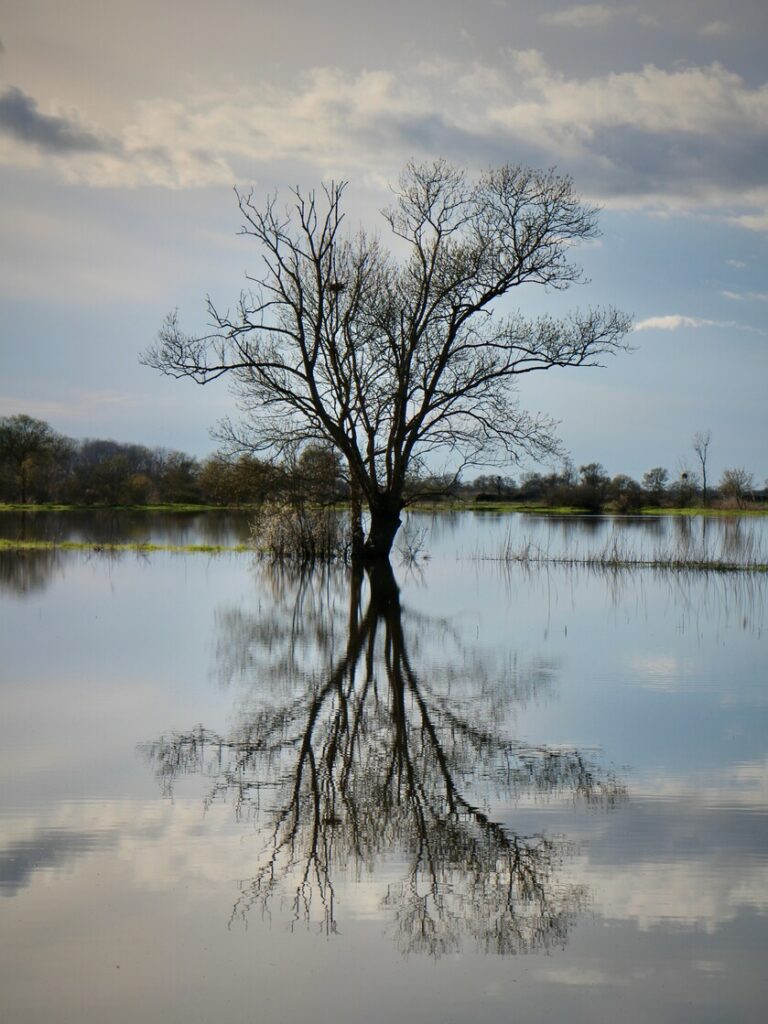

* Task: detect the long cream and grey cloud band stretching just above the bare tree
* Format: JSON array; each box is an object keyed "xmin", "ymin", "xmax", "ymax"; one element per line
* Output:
[{"xmin": 5, "ymin": 53, "xmax": 768, "ymax": 230}]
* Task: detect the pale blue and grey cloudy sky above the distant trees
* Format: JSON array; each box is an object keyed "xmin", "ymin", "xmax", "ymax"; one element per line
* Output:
[{"xmin": 0, "ymin": 0, "xmax": 768, "ymax": 482}]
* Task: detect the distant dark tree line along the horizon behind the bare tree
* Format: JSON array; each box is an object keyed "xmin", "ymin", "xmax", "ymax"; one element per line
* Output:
[{"xmin": 0, "ymin": 415, "xmax": 768, "ymax": 512}]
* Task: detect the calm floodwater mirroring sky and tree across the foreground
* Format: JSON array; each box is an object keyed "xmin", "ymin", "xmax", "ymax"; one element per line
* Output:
[{"xmin": 0, "ymin": 514, "xmax": 768, "ymax": 1024}]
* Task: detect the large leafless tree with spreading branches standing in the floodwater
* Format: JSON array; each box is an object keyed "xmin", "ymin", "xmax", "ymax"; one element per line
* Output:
[{"xmin": 143, "ymin": 161, "xmax": 630, "ymax": 558}]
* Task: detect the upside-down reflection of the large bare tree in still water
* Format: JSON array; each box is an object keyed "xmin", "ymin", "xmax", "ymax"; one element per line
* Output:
[{"xmin": 145, "ymin": 564, "xmax": 623, "ymax": 955}]
